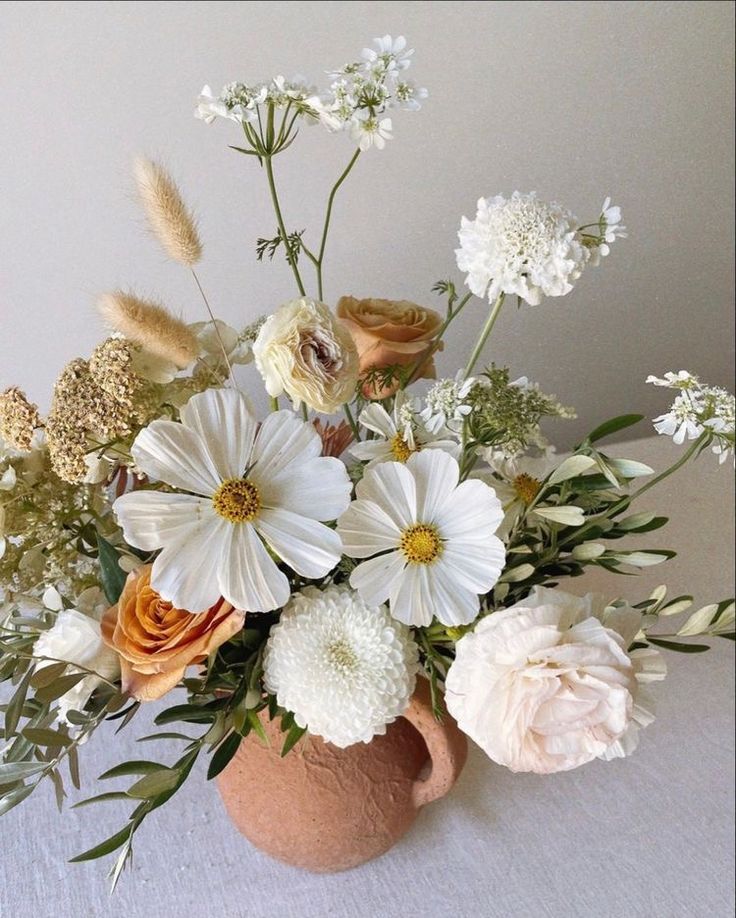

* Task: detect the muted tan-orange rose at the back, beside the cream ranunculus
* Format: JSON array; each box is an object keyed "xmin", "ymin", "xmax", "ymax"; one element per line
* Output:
[{"xmin": 337, "ymin": 296, "xmax": 443, "ymax": 399}]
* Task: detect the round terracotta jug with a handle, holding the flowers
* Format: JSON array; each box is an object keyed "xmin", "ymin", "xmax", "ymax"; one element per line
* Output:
[{"xmin": 217, "ymin": 679, "xmax": 468, "ymax": 873}]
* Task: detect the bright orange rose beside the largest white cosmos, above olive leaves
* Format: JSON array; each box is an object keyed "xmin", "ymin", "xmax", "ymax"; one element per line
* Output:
[{"xmin": 101, "ymin": 564, "xmax": 245, "ymax": 701}]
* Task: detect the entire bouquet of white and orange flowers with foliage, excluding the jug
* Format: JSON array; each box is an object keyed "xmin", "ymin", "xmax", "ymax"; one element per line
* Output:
[{"xmin": 0, "ymin": 36, "xmax": 734, "ymax": 892}]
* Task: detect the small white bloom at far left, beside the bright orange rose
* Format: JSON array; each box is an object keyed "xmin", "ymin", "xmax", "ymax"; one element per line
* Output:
[{"xmin": 33, "ymin": 590, "xmax": 120, "ymax": 723}]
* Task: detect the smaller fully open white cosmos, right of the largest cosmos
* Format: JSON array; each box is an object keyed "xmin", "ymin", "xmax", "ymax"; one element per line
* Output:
[{"xmin": 337, "ymin": 449, "xmax": 505, "ymax": 626}]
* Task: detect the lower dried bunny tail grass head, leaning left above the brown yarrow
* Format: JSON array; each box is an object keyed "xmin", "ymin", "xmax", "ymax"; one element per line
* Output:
[{"xmin": 97, "ymin": 290, "xmax": 199, "ymax": 370}]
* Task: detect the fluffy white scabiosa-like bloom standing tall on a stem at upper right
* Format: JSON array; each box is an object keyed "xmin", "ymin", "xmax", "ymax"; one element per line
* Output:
[{"xmin": 455, "ymin": 191, "xmax": 590, "ymax": 306}]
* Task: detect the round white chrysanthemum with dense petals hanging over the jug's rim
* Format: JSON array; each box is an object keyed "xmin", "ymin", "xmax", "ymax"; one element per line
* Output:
[{"xmin": 263, "ymin": 586, "xmax": 418, "ymax": 748}]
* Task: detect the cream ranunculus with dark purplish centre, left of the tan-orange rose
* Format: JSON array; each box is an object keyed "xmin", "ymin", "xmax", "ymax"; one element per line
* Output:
[{"xmin": 253, "ymin": 297, "xmax": 358, "ymax": 414}]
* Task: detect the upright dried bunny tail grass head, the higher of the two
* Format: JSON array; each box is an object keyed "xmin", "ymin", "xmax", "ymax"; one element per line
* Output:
[{"xmin": 134, "ymin": 157, "xmax": 202, "ymax": 268}]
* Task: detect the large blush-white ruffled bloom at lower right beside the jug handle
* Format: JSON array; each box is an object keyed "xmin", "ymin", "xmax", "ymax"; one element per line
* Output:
[{"xmin": 446, "ymin": 588, "xmax": 666, "ymax": 774}]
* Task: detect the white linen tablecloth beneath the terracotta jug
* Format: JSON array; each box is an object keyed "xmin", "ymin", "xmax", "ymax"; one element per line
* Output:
[{"xmin": 0, "ymin": 439, "xmax": 734, "ymax": 918}]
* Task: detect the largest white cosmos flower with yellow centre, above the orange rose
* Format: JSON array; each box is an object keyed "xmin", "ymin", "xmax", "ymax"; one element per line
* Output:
[{"xmin": 114, "ymin": 389, "xmax": 351, "ymax": 612}]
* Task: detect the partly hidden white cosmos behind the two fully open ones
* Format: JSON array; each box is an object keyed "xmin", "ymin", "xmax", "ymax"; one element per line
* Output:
[{"xmin": 349, "ymin": 391, "xmax": 460, "ymax": 468}]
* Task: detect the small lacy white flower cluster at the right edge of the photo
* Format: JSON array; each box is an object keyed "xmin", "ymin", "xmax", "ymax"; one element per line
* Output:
[{"xmin": 647, "ymin": 370, "xmax": 736, "ymax": 463}]
